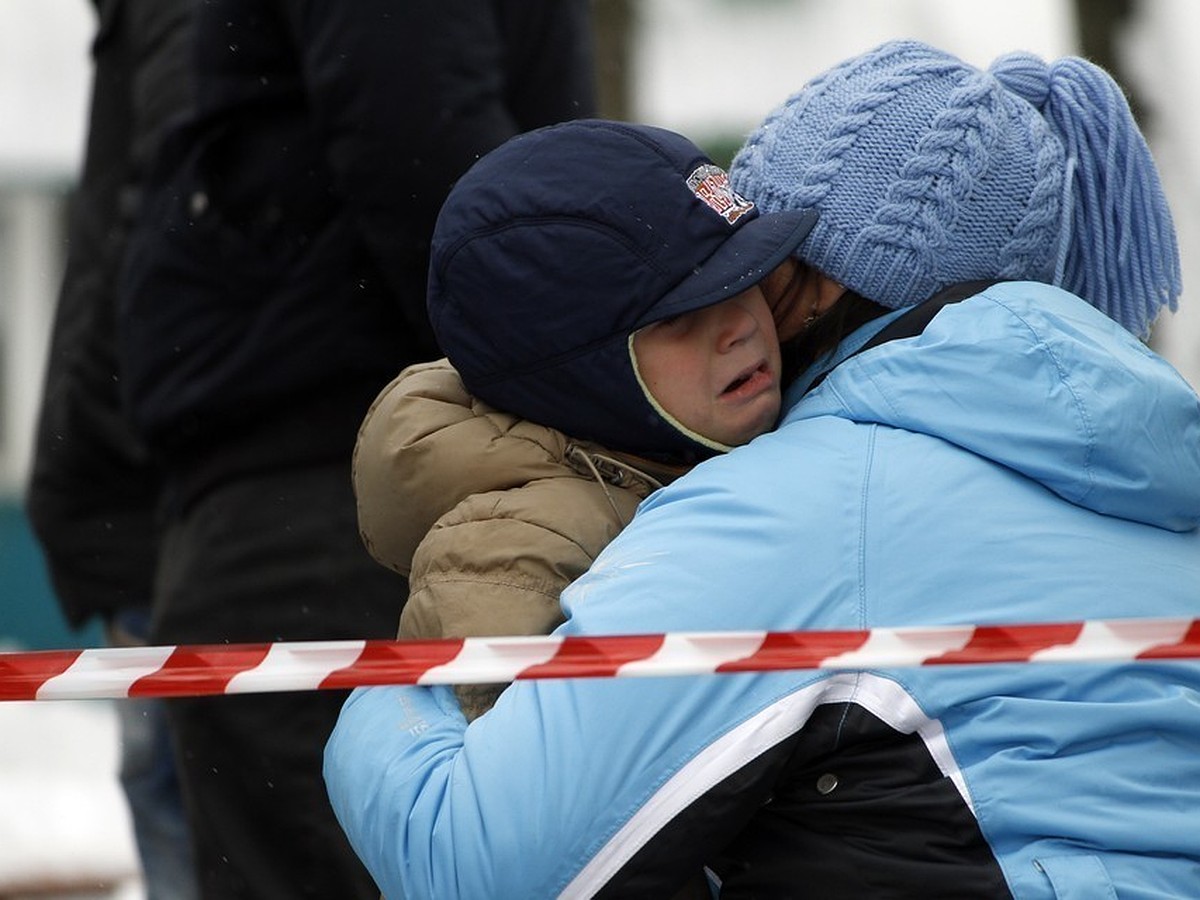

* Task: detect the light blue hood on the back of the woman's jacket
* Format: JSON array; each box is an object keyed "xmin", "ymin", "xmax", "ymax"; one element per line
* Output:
[{"xmin": 787, "ymin": 282, "xmax": 1200, "ymax": 532}]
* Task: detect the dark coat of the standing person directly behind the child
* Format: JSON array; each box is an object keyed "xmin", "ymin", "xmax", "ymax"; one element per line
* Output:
[{"xmin": 121, "ymin": 0, "xmax": 593, "ymax": 513}]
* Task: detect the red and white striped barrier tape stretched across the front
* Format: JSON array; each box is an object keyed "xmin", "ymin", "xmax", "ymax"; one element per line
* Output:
[{"xmin": 0, "ymin": 619, "xmax": 1200, "ymax": 701}]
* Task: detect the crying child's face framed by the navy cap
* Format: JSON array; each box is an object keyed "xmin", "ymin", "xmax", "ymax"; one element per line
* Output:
[{"xmin": 634, "ymin": 286, "xmax": 780, "ymax": 446}]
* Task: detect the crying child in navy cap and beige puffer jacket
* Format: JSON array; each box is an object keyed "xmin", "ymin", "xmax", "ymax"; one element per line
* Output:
[{"xmin": 354, "ymin": 120, "xmax": 812, "ymax": 719}]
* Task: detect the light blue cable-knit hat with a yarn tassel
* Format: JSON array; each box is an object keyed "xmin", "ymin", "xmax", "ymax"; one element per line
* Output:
[{"xmin": 730, "ymin": 41, "xmax": 1181, "ymax": 337}]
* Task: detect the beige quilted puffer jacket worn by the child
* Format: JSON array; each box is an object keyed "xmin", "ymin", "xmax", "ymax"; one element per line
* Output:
[{"xmin": 354, "ymin": 360, "xmax": 685, "ymax": 712}]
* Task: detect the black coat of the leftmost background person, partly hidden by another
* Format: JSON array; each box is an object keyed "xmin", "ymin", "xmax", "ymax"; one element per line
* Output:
[{"xmin": 25, "ymin": 0, "xmax": 197, "ymax": 626}]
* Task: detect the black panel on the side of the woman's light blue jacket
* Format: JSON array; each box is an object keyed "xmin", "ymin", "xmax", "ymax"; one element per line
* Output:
[{"xmin": 599, "ymin": 703, "xmax": 1010, "ymax": 900}]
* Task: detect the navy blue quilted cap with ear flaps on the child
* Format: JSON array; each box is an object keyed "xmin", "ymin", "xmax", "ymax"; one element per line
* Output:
[{"xmin": 428, "ymin": 120, "xmax": 815, "ymax": 458}]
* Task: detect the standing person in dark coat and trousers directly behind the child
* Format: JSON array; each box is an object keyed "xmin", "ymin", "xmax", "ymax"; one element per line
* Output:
[{"xmin": 119, "ymin": 0, "xmax": 594, "ymax": 900}]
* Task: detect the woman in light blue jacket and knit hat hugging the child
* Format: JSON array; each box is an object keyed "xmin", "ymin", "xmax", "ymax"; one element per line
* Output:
[{"xmin": 325, "ymin": 42, "xmax": 1200, "ymax": 900}]
